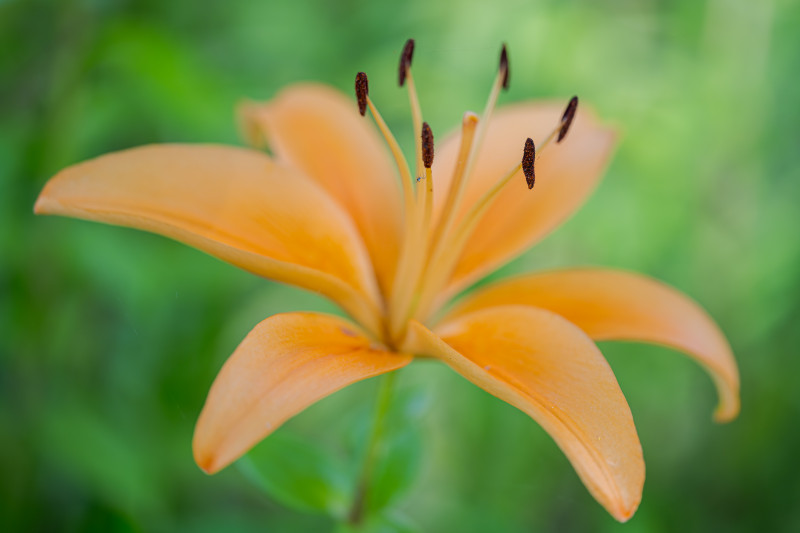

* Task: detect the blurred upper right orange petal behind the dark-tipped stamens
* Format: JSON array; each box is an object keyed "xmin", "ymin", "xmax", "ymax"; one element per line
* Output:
[{"xmin": 433, "ymin": 102, "xmax": 615, "ymax": 300}]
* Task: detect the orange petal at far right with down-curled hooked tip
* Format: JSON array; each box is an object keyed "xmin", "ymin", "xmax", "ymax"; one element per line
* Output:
[{"xmin": 445, "ymin": 268, "xmax": 739, "ymax": 421}]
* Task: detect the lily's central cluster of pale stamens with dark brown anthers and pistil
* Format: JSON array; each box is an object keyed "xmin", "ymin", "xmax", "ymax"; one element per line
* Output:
[{"xmin": 355, "ymin": 39, "xmax": 578, "ymax": 346}]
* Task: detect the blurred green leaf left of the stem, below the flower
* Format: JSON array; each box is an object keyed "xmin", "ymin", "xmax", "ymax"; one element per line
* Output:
[{"xmin": 237, "ymin": 430, "xmax": 352, "ymax": 518}]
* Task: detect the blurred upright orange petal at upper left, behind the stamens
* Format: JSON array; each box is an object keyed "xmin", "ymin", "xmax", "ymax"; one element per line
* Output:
[{"xmin": 240, "ymin": 83, "xmax": 402, "ymax": 294}]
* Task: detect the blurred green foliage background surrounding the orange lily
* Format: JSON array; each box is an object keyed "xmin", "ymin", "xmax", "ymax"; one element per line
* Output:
[{"xmin": 0, "ymin": 0, "xmax": 800, "ymax": 532}]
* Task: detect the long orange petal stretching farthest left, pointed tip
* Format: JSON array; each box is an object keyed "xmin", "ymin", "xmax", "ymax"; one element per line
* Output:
[{"xmin": 34, "ymin": 144, "xmax": 386, "ymax": 332}]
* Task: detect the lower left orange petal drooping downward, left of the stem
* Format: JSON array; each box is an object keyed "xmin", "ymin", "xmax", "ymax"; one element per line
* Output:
[{"xmin": 193, "ymin": 313, "xmax": 411, "ymax": 474}]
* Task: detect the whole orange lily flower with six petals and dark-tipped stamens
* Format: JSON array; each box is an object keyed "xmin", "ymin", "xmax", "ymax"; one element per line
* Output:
[{"xmin": 35, "ymin": 41, "xmax": 739, "ymax": 521}]
